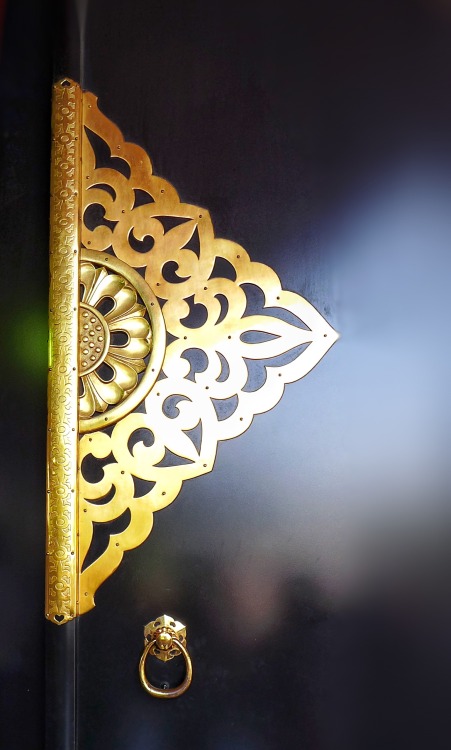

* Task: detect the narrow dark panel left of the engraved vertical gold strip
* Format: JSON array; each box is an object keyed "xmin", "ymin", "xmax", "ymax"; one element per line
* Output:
[{"xmin": 0, "ymin": 0, "xmax": 52, "ymax": 750}]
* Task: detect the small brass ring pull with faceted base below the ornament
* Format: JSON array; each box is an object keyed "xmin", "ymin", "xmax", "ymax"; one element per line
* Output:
[{"xmin": 139, "ymin": 615, "xmax": 193, "ymax": 698}]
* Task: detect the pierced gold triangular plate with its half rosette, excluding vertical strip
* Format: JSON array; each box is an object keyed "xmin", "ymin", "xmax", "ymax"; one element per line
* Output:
[{"xmin": 46, "ymin": 79, "xmax": 338, "ymax": 614}]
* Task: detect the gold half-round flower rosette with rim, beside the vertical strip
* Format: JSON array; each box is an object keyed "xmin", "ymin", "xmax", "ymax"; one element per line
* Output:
[{"xmin": 79, "ymin": 250, "xmax": 165, "ymax": 432}]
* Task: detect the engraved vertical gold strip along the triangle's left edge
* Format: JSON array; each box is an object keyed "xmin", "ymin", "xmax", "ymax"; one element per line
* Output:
[{"xmin": 45, "ymin": 79, "xmax": 82, "ymax": 625}]
